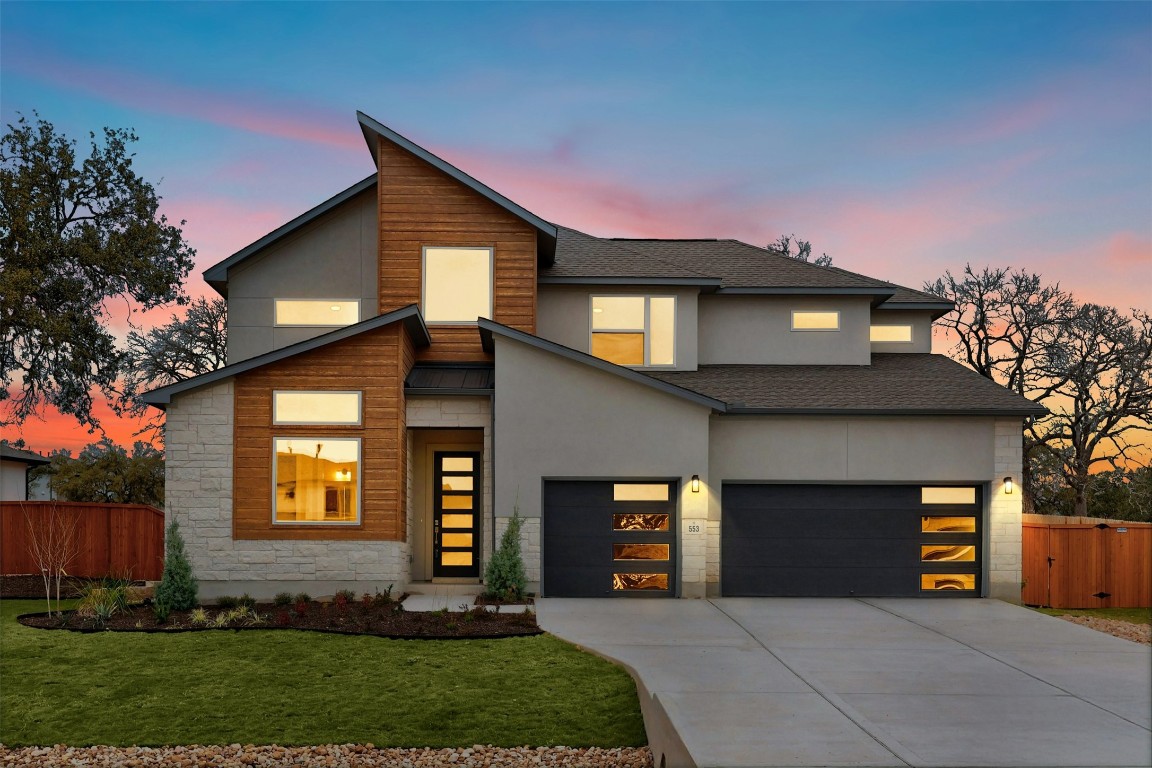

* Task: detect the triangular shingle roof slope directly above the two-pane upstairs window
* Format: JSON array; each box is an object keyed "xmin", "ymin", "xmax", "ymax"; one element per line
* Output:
[{"xmin": 539, "ymin": 227, "xmax": 721, "ymax": 288}]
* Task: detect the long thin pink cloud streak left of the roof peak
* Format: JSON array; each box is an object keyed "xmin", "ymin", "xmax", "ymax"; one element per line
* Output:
[{"xmin": 5, "ymin": 43, "xmax": 364, "ymax": 152}]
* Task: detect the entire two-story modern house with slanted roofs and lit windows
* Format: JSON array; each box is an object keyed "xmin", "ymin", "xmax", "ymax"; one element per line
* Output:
[{"xmin": 147, "ymin": 114, "xmax": 1044, "ymax": 600}]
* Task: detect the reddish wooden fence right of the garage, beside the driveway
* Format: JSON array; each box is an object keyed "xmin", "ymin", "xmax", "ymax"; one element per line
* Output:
[{"xmin": 1022, "ymin": 515, "xmax": 1152, "ymax": 608}]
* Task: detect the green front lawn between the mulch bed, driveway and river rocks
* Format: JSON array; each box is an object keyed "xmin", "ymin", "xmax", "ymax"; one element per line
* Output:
[{"xmin": 0, "ymin": 600, "xmax": 647, "ymax": 747}]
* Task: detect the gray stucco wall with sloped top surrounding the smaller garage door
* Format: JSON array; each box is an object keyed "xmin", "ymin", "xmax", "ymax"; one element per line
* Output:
[{"xmin": 493, "ymin": 336, "xmax": 711, "ymax": 596}]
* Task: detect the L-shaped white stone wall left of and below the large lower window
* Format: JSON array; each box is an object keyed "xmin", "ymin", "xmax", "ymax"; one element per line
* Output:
[{"xmin": 165, "ymin": 380, "xmax": 408, "ymax": 599}]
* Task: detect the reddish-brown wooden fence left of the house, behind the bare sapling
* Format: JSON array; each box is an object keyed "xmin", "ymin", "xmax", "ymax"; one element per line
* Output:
[{"xmin": 0, "ymin": 501, "xmax": 164, "ymax": 581}]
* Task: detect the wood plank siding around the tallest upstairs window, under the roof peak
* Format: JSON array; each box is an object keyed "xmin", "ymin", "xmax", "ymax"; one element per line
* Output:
[{"xmin": 378, "ymin": 138, "xmax": 537, "ymax": 360}]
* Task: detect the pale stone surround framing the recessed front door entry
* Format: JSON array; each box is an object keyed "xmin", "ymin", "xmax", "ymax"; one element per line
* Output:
[{"xmin": 406, "ymin": 395, "xmax": 502, "ymax": 578}]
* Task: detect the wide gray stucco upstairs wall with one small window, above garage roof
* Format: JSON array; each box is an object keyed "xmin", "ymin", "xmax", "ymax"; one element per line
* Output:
[{"xmin": 698, "ymin": 295, "xmax": 871, "ymax": 365}]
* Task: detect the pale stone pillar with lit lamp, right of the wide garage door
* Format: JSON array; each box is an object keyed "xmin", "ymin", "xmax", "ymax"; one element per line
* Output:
[{"xmin": 985, "ymin": 419, "xmax": 1024, "ymax": 602}]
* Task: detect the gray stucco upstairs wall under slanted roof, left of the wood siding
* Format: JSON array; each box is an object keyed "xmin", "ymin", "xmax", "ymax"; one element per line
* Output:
[{"xmin": 228, "ymin": 191, "xmax": 379, "ymax": 363}]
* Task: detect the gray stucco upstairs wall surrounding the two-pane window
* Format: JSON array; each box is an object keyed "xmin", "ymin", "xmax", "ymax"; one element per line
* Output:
[{"xmin": 536, "ymin": 286, "xmax": 699, "ymax": 371}]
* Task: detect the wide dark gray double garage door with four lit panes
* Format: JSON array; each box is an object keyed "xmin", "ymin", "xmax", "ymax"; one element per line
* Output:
[{"xmin": 720, "ymin": 484, "xmax": 983, "ymax": 598}]
